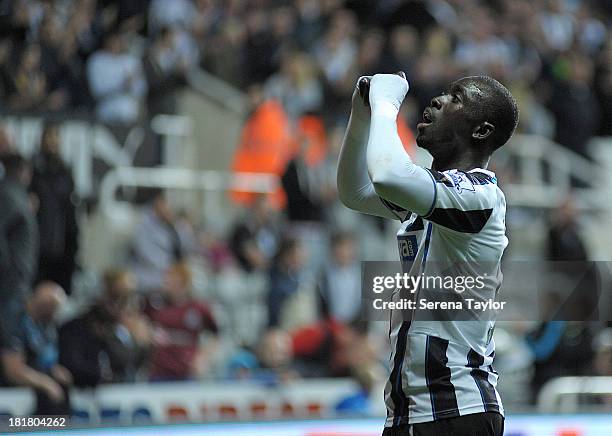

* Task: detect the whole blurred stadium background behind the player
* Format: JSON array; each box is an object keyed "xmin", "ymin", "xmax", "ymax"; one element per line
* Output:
[{"xmin": 0, "ymin": 0, "xmax": 612, "ymax": 436}]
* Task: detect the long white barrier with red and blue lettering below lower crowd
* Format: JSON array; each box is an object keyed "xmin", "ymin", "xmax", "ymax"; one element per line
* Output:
[{"xmin": 0, "ymin": 379, "xmax": 359, "ymax": 425}]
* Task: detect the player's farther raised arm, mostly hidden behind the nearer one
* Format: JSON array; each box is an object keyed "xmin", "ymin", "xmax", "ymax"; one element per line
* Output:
[{"xmin": 337, "ymin": 77, "xmax": 397, "ymax": 219}]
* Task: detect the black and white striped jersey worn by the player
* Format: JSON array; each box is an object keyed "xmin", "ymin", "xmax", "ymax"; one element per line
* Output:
[{"xmin": 382, "ymin": 168, "xmax": 508, "ymax": 427}]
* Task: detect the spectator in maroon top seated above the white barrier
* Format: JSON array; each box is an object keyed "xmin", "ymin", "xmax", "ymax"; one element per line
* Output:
[{"xmin": 145, "ymin": 263, "xmax": 218, "ymax": 381}]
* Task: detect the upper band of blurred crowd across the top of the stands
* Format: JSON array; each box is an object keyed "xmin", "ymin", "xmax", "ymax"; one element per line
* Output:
[{"xmin": 0, "ymin": 0, "xmax": 612, "ymax": 155}]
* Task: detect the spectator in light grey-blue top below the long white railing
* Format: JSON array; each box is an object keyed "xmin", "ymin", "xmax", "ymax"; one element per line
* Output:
[{"xmin": 130, "ymin": 190, "xmax": 185, "ymax": 292}]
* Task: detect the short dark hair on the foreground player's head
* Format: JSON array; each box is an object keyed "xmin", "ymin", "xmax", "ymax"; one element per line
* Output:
[{"xmin": 468, "ymin": 76, "xmax": 519, "ymax": 152}]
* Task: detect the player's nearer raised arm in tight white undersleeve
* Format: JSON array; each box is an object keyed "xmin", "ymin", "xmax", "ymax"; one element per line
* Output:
[{"xmin": 366, "ymin": 74, "xmax": 436, "ymax": 216}]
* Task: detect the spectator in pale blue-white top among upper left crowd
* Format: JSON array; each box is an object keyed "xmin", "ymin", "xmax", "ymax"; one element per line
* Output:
[{"xmin": 87, "ymin": 29, "xmax": 147, "ymax": 125}]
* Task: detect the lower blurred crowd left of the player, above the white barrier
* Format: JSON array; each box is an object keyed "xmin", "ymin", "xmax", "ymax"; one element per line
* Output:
[{"xmin": 0, "ymin": 135, "xmax": 380, "ymax": 414}]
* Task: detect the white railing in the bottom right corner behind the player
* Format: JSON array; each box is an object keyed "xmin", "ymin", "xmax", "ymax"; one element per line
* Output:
[{"xmin": 537, "ymin": 377, "xmax": 612, "ymax": 413}]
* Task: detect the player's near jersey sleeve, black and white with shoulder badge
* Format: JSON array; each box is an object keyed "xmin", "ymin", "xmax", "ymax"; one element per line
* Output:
[{"xmin": 424, "ymin": 170, "xmax": 497, "ymax": 233}]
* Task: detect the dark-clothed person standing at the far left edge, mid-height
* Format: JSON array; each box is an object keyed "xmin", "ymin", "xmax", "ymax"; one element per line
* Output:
[{"xmin": 0, "ymin": 154, "xmax": 38, "ymax": 333}]
